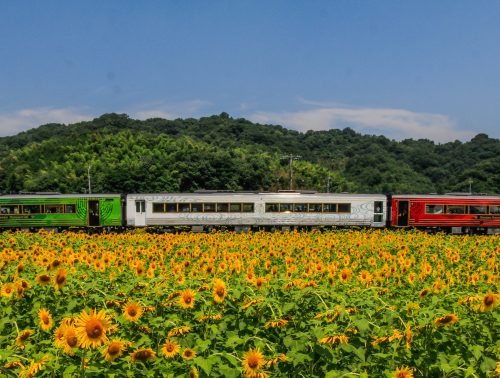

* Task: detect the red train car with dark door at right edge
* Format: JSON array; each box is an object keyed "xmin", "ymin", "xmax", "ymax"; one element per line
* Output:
[{"xmin": 390, "ymin": 194, "xmax": 500, "ymax": 234}]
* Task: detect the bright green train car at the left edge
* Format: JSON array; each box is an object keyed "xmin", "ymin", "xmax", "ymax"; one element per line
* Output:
[{"xmin": 0, "ymin": 194, "xmax": 123, "ymax": 229}]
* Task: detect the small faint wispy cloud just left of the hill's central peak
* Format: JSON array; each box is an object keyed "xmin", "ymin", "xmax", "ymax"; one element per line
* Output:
[{"xmin": 130, "ymin": 100, "xmax": 212, "ymax": 119}]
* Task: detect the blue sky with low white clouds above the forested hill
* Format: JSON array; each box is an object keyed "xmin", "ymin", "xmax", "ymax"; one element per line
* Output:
[{"xmin": 0, "ymin": 0, "xmax": 500, "ymax": 143}]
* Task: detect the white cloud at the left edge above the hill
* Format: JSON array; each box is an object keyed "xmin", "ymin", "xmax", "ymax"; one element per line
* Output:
[{"xmin": 0, "ymin": 107, "xmax": 94, "ymax": 136}]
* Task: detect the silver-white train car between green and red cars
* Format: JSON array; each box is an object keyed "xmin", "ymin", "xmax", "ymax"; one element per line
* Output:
[{"xmin": 125, "ymin": 191, "xmax": 388, "ymax": 231}]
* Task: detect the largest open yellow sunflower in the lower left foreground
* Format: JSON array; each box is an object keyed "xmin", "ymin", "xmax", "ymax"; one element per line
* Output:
[{"xmin": 75, "ymin": 309, "xmax": 110, "ymax": 349}]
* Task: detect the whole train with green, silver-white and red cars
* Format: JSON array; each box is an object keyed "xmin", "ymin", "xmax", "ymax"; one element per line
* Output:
[{"xmin": 0, "ymin": 190, "xmax": 500, "ymax": 234}]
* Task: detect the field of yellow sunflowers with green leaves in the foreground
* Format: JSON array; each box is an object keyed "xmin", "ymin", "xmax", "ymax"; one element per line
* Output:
[{"xmin": 0, "ymin": 230, "xmax": 500, "ymax": 378}]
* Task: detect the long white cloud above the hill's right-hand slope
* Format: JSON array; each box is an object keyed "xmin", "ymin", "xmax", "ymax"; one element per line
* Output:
[{"xmin": 248, "ymin": 106, "xmax": 474, "ymax": 142}]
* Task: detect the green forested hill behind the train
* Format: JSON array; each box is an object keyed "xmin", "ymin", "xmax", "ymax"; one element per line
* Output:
[{"xmin": 0, "ymin": 113, "xmax": 500, "ymax": 194}]
